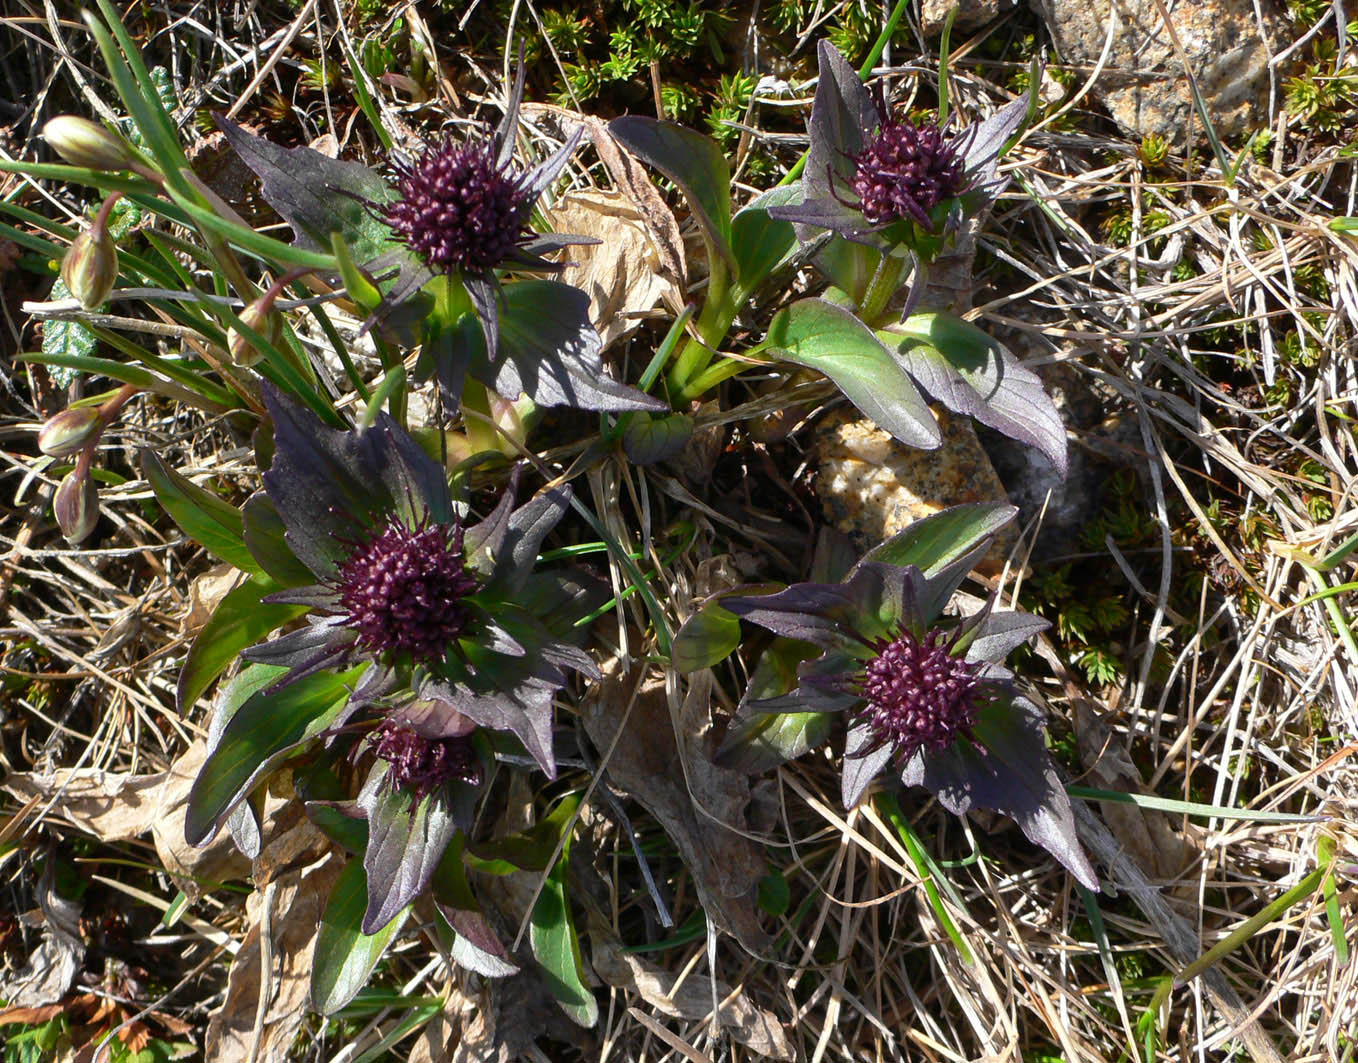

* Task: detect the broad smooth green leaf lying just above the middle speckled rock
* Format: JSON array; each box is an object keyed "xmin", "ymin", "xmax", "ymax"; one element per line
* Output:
[{"xmin": 765, "ymin": 299, "xmax": 942, "ymax": 449}]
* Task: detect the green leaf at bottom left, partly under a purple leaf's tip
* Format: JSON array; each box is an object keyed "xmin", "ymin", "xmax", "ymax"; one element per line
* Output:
[{"xmin": 311, "ymin": 861, "xmax": 410, "ymax": 1015}]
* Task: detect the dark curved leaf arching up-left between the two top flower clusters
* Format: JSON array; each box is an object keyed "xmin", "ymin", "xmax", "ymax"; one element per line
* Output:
[{"xmin": 608, "ymin": 114, "xmax": 736, "ymax": 266}]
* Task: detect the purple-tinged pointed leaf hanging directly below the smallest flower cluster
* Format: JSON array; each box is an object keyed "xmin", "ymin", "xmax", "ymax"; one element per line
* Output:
[{"xmin": 359, "ymin": 762, "xmax": 458, "ymax": 934}]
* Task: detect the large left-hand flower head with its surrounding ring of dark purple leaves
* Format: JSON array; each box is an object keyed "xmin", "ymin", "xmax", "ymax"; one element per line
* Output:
[{"xmin": 230, "ymin": 384, "xmax": 599, "ymax": 774}]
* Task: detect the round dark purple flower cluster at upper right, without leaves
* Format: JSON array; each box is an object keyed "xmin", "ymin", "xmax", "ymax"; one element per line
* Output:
[{"xmin": 851, "ymin": 121, "xmax": 967, "ymax": 228}]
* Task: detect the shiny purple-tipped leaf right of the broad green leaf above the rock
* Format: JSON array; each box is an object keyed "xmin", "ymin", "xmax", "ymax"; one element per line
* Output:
[{"xmin": 877, "ymin": 312, "xmax": 1066, "ymax": 477}]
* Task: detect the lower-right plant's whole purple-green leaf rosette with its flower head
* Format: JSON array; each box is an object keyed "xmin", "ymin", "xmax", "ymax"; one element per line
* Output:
[{"xmin": 689, "ymin": 506, "xmax": 1099, "ymax": 889}]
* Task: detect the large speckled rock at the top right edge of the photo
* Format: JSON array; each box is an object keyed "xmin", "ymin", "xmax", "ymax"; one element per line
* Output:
[{"xmin": 1029, "ymin": 0, "xmax": 1289, "ymax": 144}]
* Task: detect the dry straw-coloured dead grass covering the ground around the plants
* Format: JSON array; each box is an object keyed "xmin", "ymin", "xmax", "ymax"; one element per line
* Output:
[{"xmin": 0, "ymin": 3, "xmax": 1358, "ymax": 1063}]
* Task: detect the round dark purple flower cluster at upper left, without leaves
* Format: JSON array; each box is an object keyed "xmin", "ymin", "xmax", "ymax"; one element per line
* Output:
[{"xmin": 382, "ymin": 140, "xmax": 536, "ymax": 273}]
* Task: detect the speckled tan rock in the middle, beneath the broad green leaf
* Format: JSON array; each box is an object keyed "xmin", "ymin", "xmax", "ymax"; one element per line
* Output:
[{"xmin": 812, "ymin": 409, "xmax": 1017, "ymax": 563}]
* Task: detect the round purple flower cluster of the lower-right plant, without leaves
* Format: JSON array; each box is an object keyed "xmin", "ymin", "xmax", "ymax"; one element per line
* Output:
[{"xmin": 856, "ymin": 629, "xmax": 980, "ymax": 764}]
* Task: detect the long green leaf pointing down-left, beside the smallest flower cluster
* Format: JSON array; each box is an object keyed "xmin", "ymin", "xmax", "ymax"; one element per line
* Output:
[{"xmin": 183, "ymin": 664, "xmax": 368, "ymax": 846}]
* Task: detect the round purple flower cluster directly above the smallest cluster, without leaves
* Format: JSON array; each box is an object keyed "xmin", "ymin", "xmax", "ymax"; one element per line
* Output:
[{"xmin": 335, "ymin": 517, "xmax": 479, "ymax": 664}]
